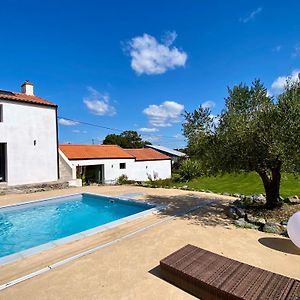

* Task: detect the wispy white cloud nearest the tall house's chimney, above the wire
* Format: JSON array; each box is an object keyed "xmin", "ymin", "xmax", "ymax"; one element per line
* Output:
[{"xmin": 83, "ymin": 87, "xmax": 116, "ymax": 116}]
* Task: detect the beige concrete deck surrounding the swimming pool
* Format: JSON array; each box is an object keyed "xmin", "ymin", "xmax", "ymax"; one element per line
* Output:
[{"xmin": 0, "ymin": 186, "xmax": 300, "ymax": 299}]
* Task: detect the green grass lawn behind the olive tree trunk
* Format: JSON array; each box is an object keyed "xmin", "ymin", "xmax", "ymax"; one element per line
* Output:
[{"xmin": 152, "ymin": 172, "xmax": 300, "ymax": 197}]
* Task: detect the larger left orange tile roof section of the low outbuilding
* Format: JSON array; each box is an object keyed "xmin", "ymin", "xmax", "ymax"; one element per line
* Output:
[{"xmin": 59, "ymin": 144, "xmax": 134, "ymax": 159}]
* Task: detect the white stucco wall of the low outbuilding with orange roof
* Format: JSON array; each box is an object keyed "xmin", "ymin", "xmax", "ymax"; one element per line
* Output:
[{"xmin": 70, "ymin": 158, "xmax": 171, "ymax": 184}]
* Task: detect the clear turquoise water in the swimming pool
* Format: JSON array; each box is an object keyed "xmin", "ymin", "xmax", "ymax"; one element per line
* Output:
[{"xmin": 0, "ymin": 194, "xmax": 153, "ymax": 257}]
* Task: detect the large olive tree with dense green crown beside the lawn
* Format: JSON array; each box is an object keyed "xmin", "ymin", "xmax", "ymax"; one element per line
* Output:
[{"xmin": 183, "ymin": 80, "xmax": 300, "ymax": 208}]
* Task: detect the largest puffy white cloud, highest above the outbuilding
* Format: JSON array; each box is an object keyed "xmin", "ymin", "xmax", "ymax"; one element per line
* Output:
[{"xmin": 127, "ymin": 32, "xmax": 187, "ymax": 75}]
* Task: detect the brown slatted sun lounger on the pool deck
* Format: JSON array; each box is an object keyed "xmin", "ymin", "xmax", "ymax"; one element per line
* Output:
[{"xmin": 160, "ymin": 245, "xmax": 300, "ymax": 300}]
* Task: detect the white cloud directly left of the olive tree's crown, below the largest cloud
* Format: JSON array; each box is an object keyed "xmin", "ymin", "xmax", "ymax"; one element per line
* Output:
[{"xmin": 143, "ymin": 101, "xmax": 184, "ymax": 127}]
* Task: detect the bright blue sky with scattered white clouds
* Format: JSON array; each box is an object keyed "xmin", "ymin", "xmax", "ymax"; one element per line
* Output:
[{"xmin": 0, "ymin": 0, "xmax": 300, "ymax": 148}]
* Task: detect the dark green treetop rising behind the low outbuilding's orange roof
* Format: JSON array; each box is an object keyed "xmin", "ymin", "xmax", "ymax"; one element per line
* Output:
[{"xmin": 103, "ymin": 130, "xmax": 151, "ymax": 148}]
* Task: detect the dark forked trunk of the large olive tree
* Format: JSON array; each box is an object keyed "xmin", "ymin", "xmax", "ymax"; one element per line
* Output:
[{"xmin": 258, "ymin": 167, "xmax": 281, "ymax": 209}]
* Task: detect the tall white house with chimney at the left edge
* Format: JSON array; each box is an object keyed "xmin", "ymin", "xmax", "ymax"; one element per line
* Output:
[{"xmin": 0, "ymin": 82, "xmax": 59, "ymax": 185}]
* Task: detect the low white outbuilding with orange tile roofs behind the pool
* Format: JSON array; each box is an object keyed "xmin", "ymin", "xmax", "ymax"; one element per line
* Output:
[{"xmin": 59, "ymin": 144, "xmax": 171, "ymax": 184}]
